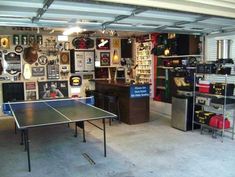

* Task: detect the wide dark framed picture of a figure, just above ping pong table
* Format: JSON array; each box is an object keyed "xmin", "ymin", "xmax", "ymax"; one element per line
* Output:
[{"xmin": 38, "ymin": 81, "xmax": 68, "ymax": 99}]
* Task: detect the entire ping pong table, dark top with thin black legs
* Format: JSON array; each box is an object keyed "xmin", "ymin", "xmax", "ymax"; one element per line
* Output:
[{"xmin": 8, "ymin": 98, "xmax": 116, "ymax": 171}]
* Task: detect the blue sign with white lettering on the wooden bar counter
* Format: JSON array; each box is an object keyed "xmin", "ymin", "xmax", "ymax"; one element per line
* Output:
[{"xmin": 130, "ymin": 85, "xmax": 149, "ymax": 98}]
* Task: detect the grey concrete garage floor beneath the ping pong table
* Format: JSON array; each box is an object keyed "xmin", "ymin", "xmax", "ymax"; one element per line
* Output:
[{"xmin": 0, "ymin": 114, "xmax": 235, "ymax": 177}]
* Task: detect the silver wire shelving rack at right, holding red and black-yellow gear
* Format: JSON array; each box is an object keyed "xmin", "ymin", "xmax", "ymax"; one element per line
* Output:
[{"xmin": 192, "ymin": 73, "xmax": 235, "ymax": 142}]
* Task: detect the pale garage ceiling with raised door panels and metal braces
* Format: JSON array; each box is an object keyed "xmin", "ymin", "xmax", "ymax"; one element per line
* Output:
[{"xmin": 0, "ymin": 0, "xmax": 235, "ymax": 34}]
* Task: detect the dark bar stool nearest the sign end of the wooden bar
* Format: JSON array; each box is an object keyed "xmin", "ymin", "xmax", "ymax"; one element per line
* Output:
[{"xmin": 105, "ymin": 95, "xmax": 121, "ymax": 125}]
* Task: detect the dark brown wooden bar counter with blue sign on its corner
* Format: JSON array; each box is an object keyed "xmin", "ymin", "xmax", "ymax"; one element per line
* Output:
[{"xmin": 95, "ymin": 81, "xmax": 149, "ymax": 124}]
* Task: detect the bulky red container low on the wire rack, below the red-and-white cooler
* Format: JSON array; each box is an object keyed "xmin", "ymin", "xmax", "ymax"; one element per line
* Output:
[{"xmin": 209, "ymin": 115, "xmax": 230, "ymax": 129}]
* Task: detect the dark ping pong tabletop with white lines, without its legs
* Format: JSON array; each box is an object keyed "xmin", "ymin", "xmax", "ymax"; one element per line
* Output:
[{"xmin": 9, "ymin": 99, "xmax": 116, "ymax": 129}]
